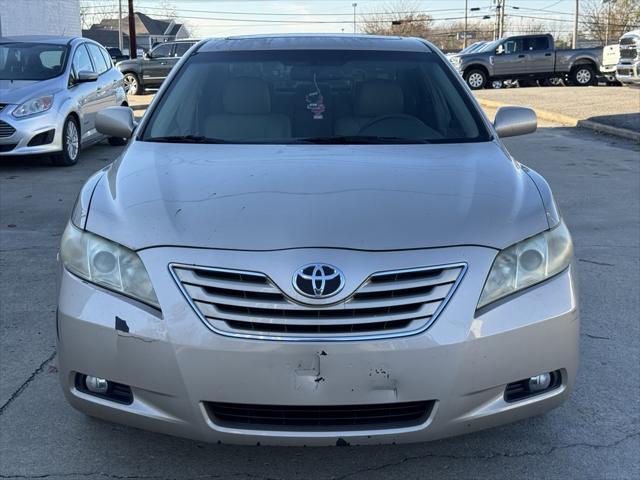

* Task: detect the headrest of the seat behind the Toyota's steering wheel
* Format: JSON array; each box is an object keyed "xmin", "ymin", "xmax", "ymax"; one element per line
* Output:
[{"xmin": 353, "ymin": 80, "xmax": 404, "ymax": 117}]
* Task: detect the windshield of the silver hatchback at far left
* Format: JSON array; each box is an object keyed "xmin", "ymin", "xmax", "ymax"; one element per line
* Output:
[{"xmin": 0, "ymin": 42, "xmax": 68, "ymax": 80}]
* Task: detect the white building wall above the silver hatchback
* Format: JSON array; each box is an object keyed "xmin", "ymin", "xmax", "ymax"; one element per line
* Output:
[{"xmin": 0, "ymin": 0, "xmax": 81, "ymax": 37}]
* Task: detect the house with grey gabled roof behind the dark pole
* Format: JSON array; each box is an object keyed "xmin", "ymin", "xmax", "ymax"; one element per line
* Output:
[{"xmin": 82, "ymin": 12, "xmax": 189, "ymax": 50}]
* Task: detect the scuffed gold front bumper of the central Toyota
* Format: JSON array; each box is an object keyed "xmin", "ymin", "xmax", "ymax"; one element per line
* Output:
[{"xmin": 57, "ymin": 247, "xmax": 579, "ymax": 445}]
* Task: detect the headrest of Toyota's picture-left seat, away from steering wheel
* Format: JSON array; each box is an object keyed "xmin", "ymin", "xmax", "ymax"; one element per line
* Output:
[{"xmin": 222, "ymin": 77, "xmax": 271, "ymax": 115}]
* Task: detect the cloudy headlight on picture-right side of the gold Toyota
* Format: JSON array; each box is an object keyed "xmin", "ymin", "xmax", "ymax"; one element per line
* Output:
[{"xmin": 478, "ymin": 221, "xmax": 573, "ymax": 308}]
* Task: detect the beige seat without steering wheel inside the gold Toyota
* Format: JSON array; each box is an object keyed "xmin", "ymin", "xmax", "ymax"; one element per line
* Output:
[{"xmin": 203, "ymin": 77, "xmax": 291, "ymax": 141}]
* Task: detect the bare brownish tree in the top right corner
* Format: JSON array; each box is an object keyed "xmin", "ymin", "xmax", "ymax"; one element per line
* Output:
[{"xmin": 581, "ymin": 0, "xmax": 640, "ymax": 44}]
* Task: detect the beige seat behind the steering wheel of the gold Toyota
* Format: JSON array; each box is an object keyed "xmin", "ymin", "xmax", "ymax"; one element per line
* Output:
[{"xmin": 334, "ymin": 80, "xmax": 404, "ymax": 136}]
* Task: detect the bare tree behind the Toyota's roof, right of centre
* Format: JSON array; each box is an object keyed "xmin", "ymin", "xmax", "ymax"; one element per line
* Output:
[{"xmin": 360, "ymin": 1, "xmax": 432, "ymax": 38}]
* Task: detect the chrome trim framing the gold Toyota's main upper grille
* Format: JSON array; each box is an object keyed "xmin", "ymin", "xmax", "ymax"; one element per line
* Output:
[{"xmin": 167, "ymin": 262, "xmax": 468, "ymax": 343}]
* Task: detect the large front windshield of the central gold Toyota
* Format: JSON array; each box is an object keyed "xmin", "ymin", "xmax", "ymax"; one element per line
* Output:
[{"xmin": 139, "ymin": 50, "xmax": 490, "ymax": 144}]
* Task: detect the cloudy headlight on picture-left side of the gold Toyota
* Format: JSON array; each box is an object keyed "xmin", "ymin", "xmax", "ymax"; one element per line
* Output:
[{"xmin": 60, "ymin": 222, "xmax": 160, "ymax": 308}]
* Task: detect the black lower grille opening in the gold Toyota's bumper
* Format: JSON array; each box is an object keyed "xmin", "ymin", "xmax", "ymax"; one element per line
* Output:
[{"xmin": 204, "ymin": 401, "xmax": 435, "ymax": 431}]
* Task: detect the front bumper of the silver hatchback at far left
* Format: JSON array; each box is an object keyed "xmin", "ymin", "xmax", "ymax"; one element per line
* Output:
[{"xmin": 0, "ymin": 105, "xmax": 62, "ymax": 156}]
